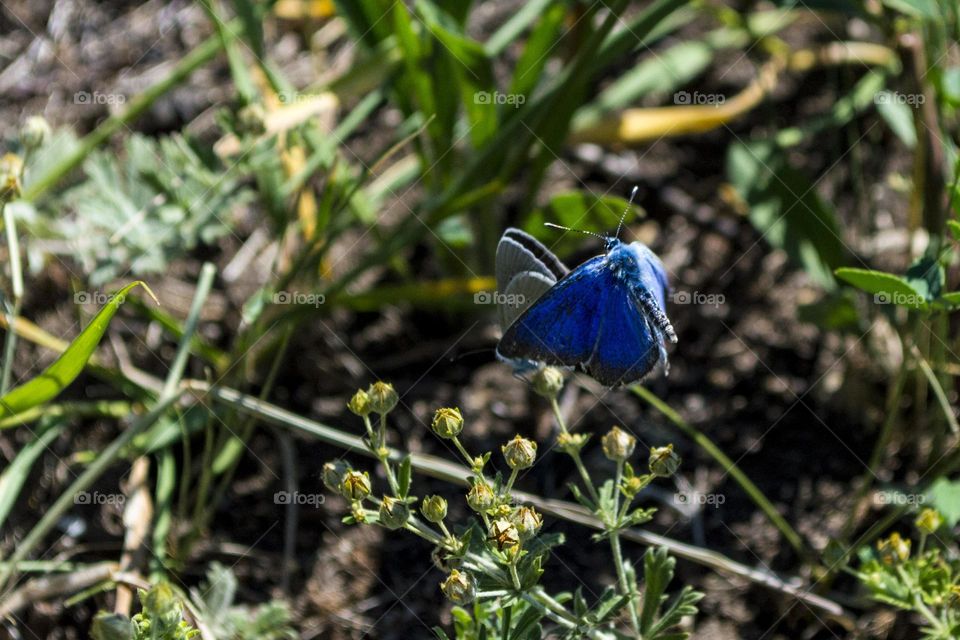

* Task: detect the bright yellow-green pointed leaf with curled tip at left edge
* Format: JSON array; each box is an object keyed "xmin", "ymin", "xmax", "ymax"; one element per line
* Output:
[{"xmin": 0, "ymin": 280, "xmax": 156, "ymax": 418}]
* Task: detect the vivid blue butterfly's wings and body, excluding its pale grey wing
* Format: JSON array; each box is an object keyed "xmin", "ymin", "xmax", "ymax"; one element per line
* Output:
[{"xmin": 497, "ymin": 190, "xmax": 677, "ymax": 387}]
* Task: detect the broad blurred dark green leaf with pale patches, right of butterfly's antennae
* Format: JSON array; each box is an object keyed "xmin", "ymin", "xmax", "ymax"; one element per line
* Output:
[{"xmin": 727, "ymin": 141, "xmax": 847, "ymax": 290}]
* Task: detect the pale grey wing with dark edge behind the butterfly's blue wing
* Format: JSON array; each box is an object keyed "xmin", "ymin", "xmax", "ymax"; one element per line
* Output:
[{"xmin": 496, "ymin": 228, "xmax": 569, "ymax": 330}]
